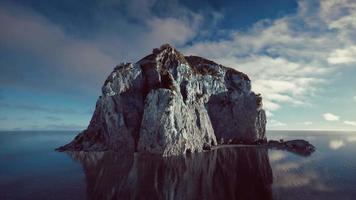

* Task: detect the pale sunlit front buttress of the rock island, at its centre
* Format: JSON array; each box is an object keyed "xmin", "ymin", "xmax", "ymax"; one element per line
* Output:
[{"xmin": 138, "ymin": 89, "xmax": 216, "ymax": 155}]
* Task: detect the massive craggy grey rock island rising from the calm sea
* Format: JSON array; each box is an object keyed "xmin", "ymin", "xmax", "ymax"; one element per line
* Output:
[{"xmin": 60, "ymin": 45, "xmax": 266, "ymax": 156}]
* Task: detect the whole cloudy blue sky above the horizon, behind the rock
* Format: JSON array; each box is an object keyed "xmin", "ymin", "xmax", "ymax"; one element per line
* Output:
[{"xmin": 0, "ymin": 0, "xmax": 356, "ymax": 130}]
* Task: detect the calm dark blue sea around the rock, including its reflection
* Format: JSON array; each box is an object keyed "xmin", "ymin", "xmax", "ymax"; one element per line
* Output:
[{"xmin": 0, "ymin": 131, "xmax": 356, "ymax": 200}]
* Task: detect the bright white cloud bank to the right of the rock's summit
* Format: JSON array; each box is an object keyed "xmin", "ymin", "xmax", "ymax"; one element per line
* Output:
[{"xmin": 185, "ymin": 0, "xmax": 356, "ymax": 115}]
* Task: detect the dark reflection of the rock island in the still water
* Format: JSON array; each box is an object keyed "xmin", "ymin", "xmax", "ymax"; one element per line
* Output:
[{"xmin": 70, "ymin": 147, "xmax": 273, "ymax": 200}]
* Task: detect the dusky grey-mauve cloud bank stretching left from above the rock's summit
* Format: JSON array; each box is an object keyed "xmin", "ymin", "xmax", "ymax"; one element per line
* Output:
[{"xmin": 0, "ymin": 0, "xmax": 204, "ymax": 94}]
